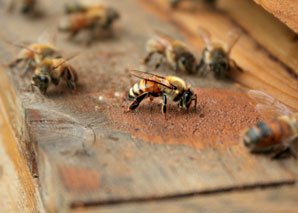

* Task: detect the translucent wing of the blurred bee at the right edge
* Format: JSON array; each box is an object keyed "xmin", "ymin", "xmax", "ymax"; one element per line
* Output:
[{"xmin": 248, "ymin": 90, "xmax": 293, "ymax": 118}]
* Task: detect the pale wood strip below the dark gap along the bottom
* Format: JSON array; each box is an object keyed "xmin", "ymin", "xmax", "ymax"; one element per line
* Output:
[{"xmin": 75, "ymin": 186, "xmax": 298, "ymax": 213}]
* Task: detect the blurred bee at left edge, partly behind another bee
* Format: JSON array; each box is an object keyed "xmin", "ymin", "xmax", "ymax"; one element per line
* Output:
[{"xmin": 0, "ymin": 32, "xmax": 61, "ymax": 75}]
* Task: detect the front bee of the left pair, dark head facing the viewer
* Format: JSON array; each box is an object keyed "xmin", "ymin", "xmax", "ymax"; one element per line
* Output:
[{"xmin": 31, "ymin": 58, "xmax": 78, "ymax": 94}]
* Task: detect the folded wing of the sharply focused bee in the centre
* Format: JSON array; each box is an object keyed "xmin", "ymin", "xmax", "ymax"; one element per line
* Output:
[{"xmin": 130, "ymin": 70, "xmax": 176, "ymax": 89}]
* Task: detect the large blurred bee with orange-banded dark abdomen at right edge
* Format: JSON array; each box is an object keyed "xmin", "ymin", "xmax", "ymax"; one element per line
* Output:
[{"xmin": 242, "ymin": 90, "xmax": 298, "ymax": 158}]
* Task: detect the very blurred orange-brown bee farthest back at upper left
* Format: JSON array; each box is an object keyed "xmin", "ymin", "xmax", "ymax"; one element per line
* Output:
[{"xmin": 58, "ymin": 5, "xmax": 120, "ymax": 39}]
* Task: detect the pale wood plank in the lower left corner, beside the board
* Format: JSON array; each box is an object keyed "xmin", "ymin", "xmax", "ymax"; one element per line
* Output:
[{"xmin": 0, "ymin": 99, "xmax": 44, "ymax": 212}]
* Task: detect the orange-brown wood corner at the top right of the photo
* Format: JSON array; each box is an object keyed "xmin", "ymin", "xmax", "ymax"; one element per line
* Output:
[{"xmin": 254, "ymin": 0, "xmax": 298, "ymax": 33}]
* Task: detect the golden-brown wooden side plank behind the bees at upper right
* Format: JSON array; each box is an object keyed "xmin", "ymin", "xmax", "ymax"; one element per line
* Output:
[{"xmin": 139, "ymin": 0, "xmax": 298, "ymax": 109}]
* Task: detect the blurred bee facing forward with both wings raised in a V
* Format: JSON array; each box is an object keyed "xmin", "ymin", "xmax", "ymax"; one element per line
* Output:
[{"xmin": 197, "ymin": 27, "xmax": 242, "ymax": 78}]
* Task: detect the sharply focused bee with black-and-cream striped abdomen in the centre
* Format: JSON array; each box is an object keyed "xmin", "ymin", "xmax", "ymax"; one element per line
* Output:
[{"xmin": 127, "ymin": 70, "xmax": 197, "ymax": 116}]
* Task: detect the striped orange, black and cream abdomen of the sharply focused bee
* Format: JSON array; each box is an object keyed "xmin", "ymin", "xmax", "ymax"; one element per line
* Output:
[{"xmin": 128, "ymin": 79, "xmax": 161, "ymax": 100}]
